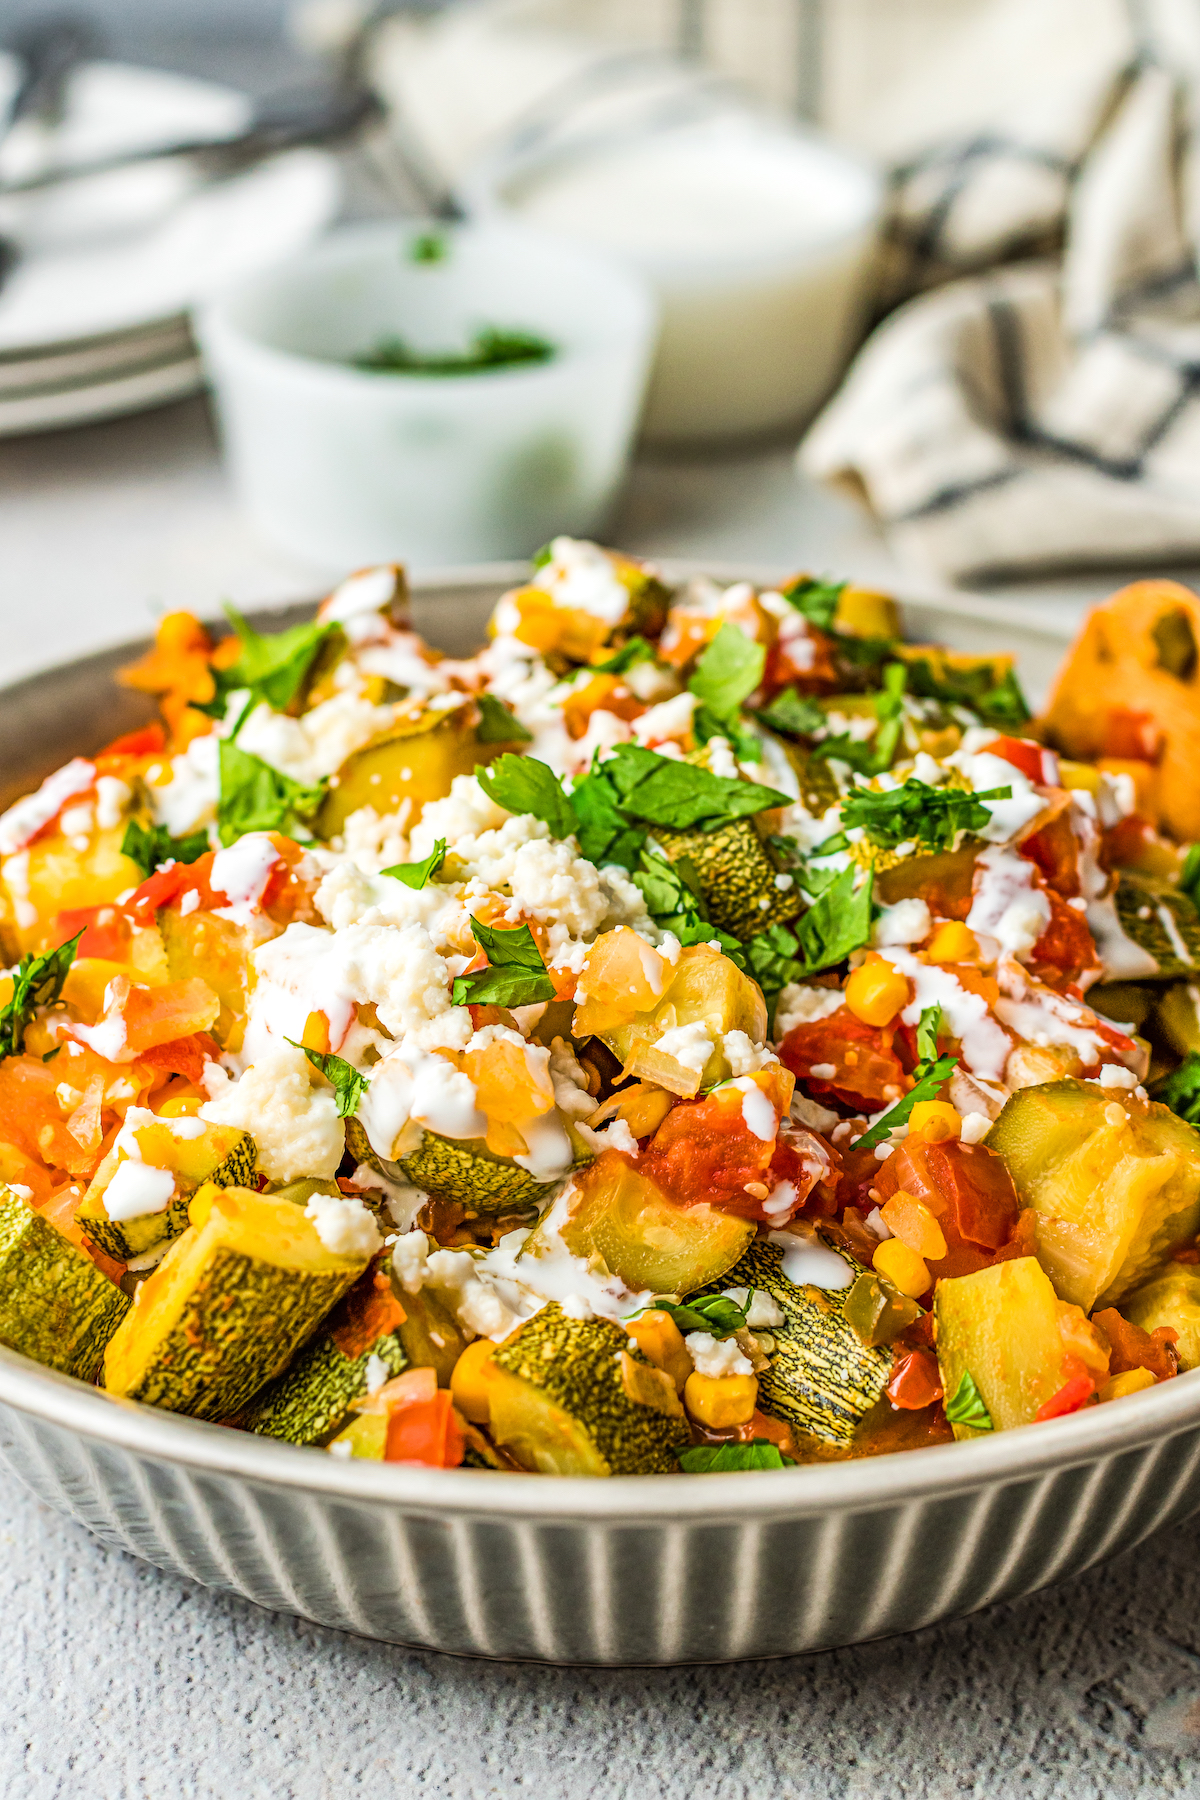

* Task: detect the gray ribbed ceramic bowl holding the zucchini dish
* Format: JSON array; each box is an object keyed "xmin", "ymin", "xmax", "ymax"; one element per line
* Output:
[{"xmin": 0, "ymin": 569, "xmax": 1200, "ymax": 1663}]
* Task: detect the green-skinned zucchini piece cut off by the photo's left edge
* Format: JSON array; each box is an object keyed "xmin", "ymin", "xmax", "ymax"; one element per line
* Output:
[{"xmin": 0, "ymin": 1188, "xmax": 130, "ymax": 1381}]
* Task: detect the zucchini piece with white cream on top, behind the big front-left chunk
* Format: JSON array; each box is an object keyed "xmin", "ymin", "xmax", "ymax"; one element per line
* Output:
[{"xmin": 76, "ymin": 1118, "xmax": 257, "ymax": 1262}]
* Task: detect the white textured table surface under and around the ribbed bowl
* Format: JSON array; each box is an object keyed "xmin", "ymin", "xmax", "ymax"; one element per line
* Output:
[{"xmin": 0, "ymin": 387, "xmax": 1200, "ymax": 1800}]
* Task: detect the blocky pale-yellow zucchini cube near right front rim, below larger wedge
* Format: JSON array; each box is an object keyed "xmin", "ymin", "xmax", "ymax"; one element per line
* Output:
[{"xmin": 934, "ymin": 1256, "xmax": 1065, "ymax": 1438}]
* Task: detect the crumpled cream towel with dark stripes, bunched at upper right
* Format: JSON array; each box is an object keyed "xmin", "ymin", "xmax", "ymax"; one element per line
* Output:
[{"xmin": 799, "ymin": 35, "xmax": 1200, "ymax": 578}]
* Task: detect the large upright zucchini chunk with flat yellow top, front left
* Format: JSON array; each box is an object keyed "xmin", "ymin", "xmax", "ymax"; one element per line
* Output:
[{"xmin": 104, "ymin": 1188, "xmax": 369, "ymax": 1418}]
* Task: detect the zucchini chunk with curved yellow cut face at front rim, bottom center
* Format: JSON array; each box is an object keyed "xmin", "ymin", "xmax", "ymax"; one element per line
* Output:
[{"xmin": 488, "ymin": 1300, "xmax": 691, "ymax": 1476}]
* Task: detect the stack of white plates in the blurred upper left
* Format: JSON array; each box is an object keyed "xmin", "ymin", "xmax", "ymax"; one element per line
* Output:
[{"xmin": 0, "ymin": 58, "xmax": 338, "ymax": 437}]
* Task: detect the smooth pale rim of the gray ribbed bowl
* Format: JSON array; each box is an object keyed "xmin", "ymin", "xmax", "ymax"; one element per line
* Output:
[{"xmin": 0, "ymin": 558, "xmax": 1200, "ymax": 1526}]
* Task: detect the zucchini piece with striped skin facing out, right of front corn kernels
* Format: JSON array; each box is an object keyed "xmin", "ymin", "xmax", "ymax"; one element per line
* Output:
[{"xmin": 711, "ymin": 1238, "xmax": 892, "ymax": 1445}]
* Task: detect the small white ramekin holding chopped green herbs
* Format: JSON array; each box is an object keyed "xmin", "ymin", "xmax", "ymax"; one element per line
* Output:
[{"xmin": 196, "ymin": 221, "xmax": 657, "ymax": 572}]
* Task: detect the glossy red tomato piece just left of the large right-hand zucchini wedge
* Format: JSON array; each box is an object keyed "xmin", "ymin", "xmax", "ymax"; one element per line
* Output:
[{"xmin": 874, "ymin": 1138, "xmax": 1020, "ymax": 1280}]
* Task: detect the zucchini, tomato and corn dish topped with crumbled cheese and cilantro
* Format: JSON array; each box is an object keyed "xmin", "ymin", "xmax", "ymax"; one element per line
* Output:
[{"xmin": 0, "ymin": 540, "xmax": 1200, "ymax": 1480}]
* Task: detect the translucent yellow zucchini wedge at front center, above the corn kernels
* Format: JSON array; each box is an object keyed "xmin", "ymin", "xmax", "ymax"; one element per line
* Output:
[{"xmin": 522, "ymin": 1152, "xmax": 756, "ymax": 1294}]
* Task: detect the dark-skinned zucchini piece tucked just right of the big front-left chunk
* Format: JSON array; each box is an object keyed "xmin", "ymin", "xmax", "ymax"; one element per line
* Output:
[{"xmin": 237, "ymin": 1253, "xmax": 408, "ymax": 1444}]
